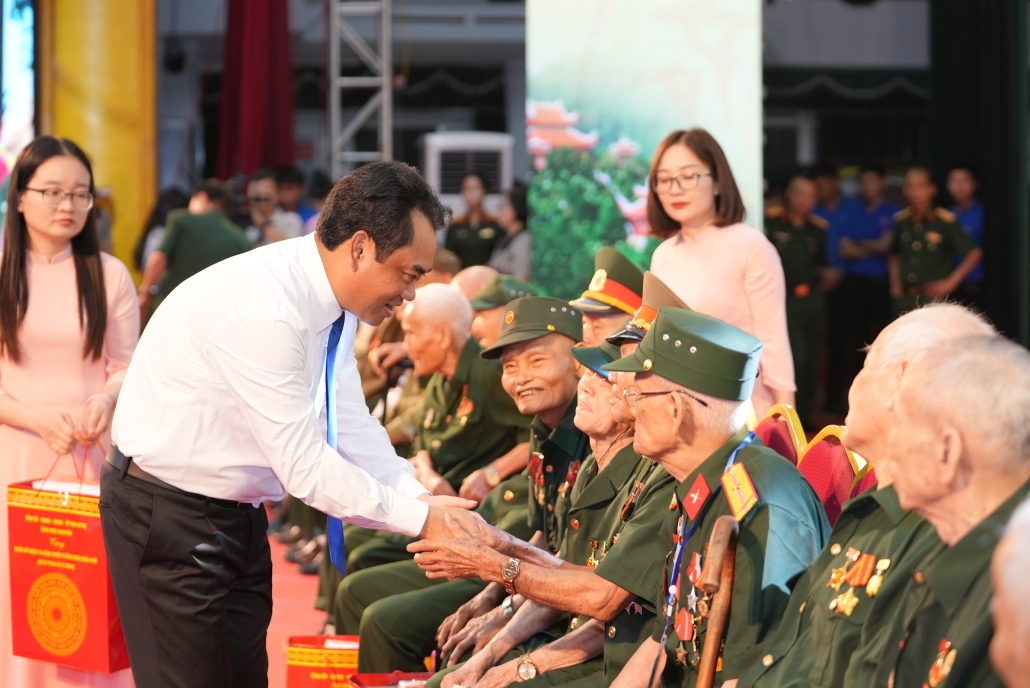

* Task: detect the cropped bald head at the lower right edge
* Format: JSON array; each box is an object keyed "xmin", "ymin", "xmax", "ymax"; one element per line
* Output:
[{"xmin": 991, "ymin": 502, "xmax": 1030, "ymax": 688}]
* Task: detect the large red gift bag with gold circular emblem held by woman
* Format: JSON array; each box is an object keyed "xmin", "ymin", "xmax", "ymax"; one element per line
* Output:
[{"xmin": 7, "ymin": 481, "xmax": 129, "ymax": 674}]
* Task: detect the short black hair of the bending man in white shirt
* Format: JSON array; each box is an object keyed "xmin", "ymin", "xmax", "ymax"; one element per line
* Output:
[{"xmin": 317, "ymin": 162, "xmax": 451, "ymax": 263}]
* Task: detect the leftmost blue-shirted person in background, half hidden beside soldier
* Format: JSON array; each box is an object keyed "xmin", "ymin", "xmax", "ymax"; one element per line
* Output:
[{"xmin": 812, "ymin": 167, "xmax": 864, "ymax": 414}]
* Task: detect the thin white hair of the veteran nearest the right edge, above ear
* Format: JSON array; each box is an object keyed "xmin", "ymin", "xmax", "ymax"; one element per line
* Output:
[{"xmin": 909, "ymin": 336, "xmax": 1030, "ymax": 470}]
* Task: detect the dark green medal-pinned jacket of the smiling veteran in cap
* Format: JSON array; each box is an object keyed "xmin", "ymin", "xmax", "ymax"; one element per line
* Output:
[{"xmin": 526, "ymin": 399, "xmax": 590, "ymax": 554}]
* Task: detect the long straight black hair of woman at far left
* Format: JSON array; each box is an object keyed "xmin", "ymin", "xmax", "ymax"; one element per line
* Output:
[{"xmin": 0, "ymin": 136, "xmax": 107, "ymax": 363}]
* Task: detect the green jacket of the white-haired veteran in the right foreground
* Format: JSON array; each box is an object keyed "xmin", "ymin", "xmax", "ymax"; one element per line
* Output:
[{"xmin": 846, "ymin": 482, "xmax": 1030, "ymax": 688}]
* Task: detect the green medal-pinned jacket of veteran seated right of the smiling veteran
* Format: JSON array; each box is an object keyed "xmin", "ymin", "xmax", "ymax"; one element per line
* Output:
[{"xmin": 558, "ymin": 444, "xmax": 668, "ymax": 631}]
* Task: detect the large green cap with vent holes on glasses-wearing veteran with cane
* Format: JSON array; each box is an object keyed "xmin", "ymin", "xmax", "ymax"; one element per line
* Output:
[{"xmin": 604, "ymin": 307, "xmax": 762, "ymax": 402}]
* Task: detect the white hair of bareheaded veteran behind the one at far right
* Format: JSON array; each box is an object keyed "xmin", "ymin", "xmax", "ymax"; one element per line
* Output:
[{"xmin": 877, "ymin": 302, "xmax": 998, "ymax": 372}]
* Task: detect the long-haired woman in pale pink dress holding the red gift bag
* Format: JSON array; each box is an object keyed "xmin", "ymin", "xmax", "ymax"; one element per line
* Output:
[{"xmin": 0, "ymin": 136, "xmax": 139, "ymax": 687}]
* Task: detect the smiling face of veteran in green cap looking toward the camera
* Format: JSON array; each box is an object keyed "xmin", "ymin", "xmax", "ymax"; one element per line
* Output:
[{"xmin": 501, "ymin": 333, "xmax": 579, "ymax": 420}]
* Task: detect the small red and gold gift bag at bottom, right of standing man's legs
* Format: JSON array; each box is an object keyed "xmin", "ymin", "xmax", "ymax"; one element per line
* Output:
[{"xmin": 286, "ymin": 635, "xmax": 358, "ymax": 688}]
